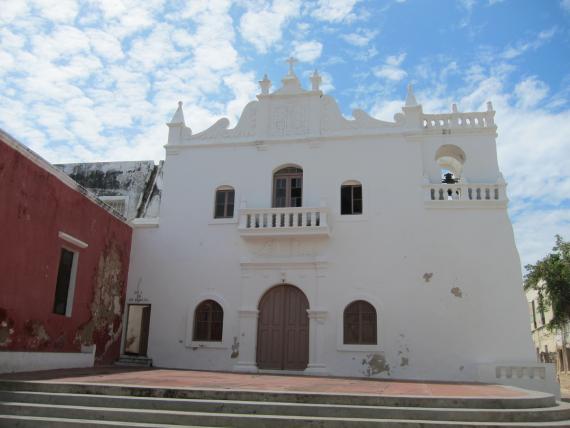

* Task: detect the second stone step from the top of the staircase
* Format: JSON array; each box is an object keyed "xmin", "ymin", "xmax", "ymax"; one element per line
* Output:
[{"xmin": 0, "ymin": 391, "xmax": 570, "ymax": 422}]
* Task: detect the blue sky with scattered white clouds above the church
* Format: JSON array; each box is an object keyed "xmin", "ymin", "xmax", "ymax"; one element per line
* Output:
[{"xmin": 0, "ymin": 0, "xmax": 570, "ymax": 263}]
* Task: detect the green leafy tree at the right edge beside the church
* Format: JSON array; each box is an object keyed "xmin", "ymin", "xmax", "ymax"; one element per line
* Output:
[{"xmin": 524, "ymin": 235, "xmax": 570, "ymax": 336}]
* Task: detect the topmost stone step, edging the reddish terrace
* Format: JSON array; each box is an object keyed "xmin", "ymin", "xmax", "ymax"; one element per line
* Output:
[{"xmin": 0, "ymin": 380, "xmax": 556, "ymax": 409}]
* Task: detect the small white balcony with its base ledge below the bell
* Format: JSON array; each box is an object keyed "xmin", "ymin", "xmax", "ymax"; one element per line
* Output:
[{"xmin": 423, "ymin": 180, "xmax": 508, "ymax": 207}]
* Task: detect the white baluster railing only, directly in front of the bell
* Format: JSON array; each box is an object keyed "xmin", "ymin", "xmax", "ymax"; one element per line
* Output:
[{"xmin": 424, "ymin": 183, "xmax": 507, "ymax": 201}]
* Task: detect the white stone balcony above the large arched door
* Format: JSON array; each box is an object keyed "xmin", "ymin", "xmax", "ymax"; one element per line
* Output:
[{"xmin": 238, "ymin": 207, "xmax": 330, "ymax": 237}]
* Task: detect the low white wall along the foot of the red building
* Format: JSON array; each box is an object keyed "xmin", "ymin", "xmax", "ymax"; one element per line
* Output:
[{"xmin": 0, "ymin": 347, "xmax": 95, "ymax": 373}]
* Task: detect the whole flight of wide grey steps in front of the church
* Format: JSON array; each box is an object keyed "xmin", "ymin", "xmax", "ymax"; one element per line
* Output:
[{"xmin": 0, "ymin": 380, "xmax": 570, "ymax": 428}]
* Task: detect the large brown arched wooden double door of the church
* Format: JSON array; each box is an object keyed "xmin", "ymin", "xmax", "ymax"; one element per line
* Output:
[{"xmin": 257, "ymin": 284, "xmax": 309, "ymax": 370}]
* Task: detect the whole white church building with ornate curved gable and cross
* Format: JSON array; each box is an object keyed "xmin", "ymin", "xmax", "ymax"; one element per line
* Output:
[{"xmin": 123, "ymin": 61, "xmax": 556, "ymax": 392}]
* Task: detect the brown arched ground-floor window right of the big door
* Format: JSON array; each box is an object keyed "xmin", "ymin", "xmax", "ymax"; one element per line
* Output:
[{"xmin": 343, "ymin": 300, "xmax": 377, "ymax": 345}]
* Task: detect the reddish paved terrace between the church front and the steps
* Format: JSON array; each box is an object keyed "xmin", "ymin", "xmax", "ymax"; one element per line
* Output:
[{"xmin": 0, "ymin": 367, "xmax": 528, "ymax": 398}]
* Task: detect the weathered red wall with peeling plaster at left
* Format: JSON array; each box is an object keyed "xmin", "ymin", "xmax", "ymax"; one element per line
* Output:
[{"xmin": 0, "ymin": 139, "xmax": 132, "ymax": 364}]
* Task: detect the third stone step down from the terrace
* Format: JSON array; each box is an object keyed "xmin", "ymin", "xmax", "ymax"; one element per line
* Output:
[{"xmin": 0, "ymin": 403, "xmax": 570, "ymax": 428}]
